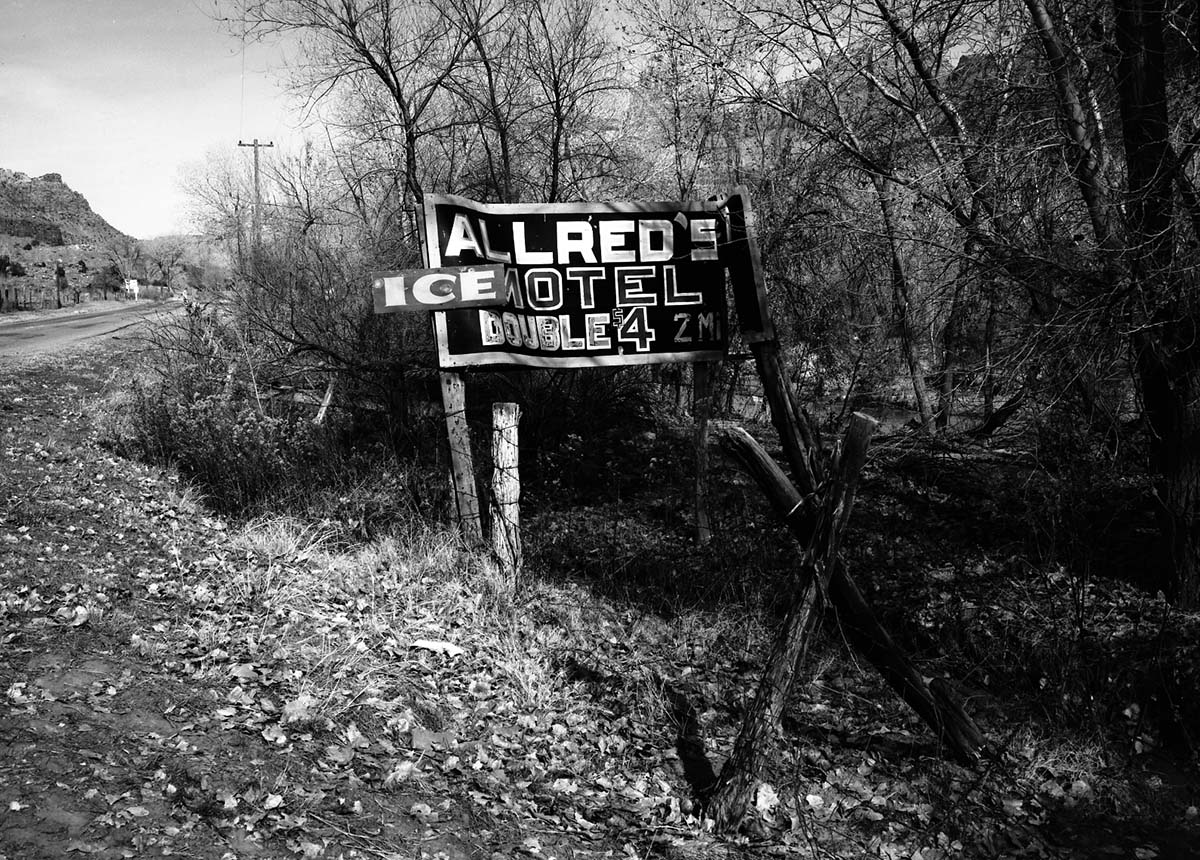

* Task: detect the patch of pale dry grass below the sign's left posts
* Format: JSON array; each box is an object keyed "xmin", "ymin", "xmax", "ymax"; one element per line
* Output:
[{"xmin": 184, "ymin": 517, "xmax": 573, "ymax": 721}]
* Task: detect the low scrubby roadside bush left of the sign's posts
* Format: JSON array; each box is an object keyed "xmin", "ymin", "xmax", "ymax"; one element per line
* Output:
[{"xmin": 108, "ymin": 297, "xmax": 446, "ymax": 542}]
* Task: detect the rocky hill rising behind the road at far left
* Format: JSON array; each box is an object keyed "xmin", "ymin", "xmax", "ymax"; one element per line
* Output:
[{"xmin": 0, "ymin": 168, "xmax": 126, "ymax": 245}]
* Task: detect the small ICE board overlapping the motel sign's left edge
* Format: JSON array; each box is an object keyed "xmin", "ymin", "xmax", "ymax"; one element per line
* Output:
[{"xmin": 372, "ymin": 265, "xmax": 508, "ymax": 313}]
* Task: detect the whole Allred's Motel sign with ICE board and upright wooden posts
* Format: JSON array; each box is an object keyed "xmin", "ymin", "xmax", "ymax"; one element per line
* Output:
[{"xmin": 373, "ymin": 194, "xmax": 728, "ymax": 556}]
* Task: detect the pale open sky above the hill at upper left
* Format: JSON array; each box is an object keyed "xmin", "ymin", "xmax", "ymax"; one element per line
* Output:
[{"xmin": 0, "ymin": 0, "xmax": 300, "ymax": 239}]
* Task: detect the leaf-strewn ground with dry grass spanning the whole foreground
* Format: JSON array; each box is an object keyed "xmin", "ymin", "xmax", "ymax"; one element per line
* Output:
[{"xmin": 0, "ymin": 338, "xmax": 1200, "ymax": 860}]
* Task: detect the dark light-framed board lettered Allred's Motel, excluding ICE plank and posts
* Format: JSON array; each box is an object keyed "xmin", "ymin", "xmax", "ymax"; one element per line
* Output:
[{"xmin": 421, "ymin": 194, "xmax": 726, "ymax": 369}]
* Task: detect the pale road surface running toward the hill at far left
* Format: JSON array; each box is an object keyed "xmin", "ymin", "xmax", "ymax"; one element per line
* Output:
[{"xmin": 0, "ymin": 301, "xmax": 179, "ymax": 357}]
